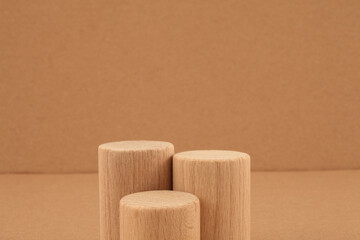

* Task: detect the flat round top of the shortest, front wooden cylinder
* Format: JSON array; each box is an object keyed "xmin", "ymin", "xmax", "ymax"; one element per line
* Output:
[{"xmin": 120, "ymin": 190, "xmax": 199, "ymax": 208}]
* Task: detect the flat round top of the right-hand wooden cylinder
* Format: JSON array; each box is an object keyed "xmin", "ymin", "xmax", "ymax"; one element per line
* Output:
[{"xmin": 174, "ymin": 150, "xmax": 250, "ymax": 161}]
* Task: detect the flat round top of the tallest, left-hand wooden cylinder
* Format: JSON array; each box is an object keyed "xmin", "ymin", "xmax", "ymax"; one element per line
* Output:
[{"xmin": 99, "ymin": 140, "xmax": 174, "ymax": 152}]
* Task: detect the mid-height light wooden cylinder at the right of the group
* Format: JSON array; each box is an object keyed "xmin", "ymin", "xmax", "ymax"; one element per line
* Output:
[{"xmin": 173, "ymin": 150, "xmax": 250, "ymax": 240}]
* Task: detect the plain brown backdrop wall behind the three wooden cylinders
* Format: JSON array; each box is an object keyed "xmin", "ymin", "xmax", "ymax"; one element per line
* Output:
[{"xmin": 0, "ymin": 0, "xmax": 360, "ymax": 172}]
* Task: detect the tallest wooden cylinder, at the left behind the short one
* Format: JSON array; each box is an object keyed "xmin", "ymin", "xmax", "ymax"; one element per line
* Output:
[{"xmin": 99, "ymin": 141, "xmax": 174, "ymax": 240}]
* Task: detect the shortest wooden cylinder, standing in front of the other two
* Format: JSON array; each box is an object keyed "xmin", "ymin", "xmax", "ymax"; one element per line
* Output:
[{"xmin": 120, "ymin": 191, "xmax": 200, "ymax": 240}]
